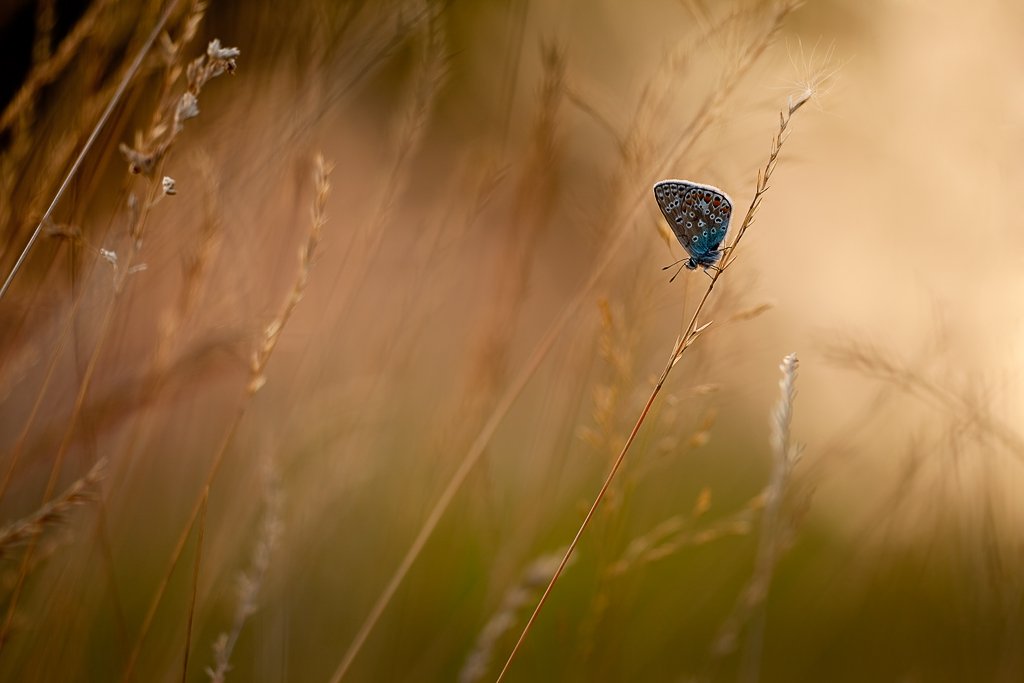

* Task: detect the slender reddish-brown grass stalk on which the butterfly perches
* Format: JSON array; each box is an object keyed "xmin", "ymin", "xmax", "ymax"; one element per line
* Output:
[{"xmin": 498, "ymin": 88, "xmax": 810, "ymax": 681}]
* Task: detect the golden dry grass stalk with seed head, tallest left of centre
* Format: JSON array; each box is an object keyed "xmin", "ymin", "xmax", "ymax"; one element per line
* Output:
[{"xmin": 122, "ymin": 155, "xmax": 332, "ymax": 681}]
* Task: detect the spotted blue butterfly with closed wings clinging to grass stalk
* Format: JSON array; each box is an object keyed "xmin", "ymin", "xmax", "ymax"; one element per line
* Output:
[{"xmin": 654, "ymin": 180, "xmax": 732, "ymax": 282}]
